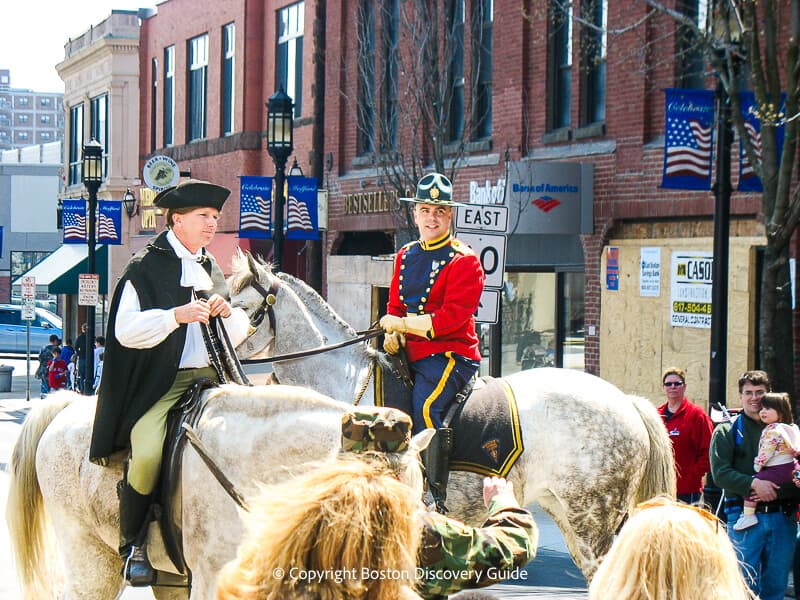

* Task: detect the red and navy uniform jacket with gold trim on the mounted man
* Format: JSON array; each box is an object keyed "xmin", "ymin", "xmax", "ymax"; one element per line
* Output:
[{"xmin": 387, "ymin": 234, "xmax": 484, "ymax": 362}]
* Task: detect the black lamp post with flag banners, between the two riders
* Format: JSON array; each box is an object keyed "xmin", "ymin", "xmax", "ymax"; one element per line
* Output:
[{"xmin": 267, "ymin": 89, "xmax": 294, "ymax": 271}]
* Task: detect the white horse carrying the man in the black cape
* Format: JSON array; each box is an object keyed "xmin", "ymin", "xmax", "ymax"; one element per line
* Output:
[{"xmin": 6, "ymin": 385, "xmax": 378, "ymax": 600}]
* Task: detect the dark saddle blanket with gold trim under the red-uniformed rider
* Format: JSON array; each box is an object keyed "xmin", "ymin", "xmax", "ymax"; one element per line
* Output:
[{"xmin": 375, "ymin": 369, "xmax": 525, "ymax": 477}]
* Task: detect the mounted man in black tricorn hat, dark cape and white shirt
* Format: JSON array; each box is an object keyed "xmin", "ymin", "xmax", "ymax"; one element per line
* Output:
[{"xmin": 89, "ymin": 180, "xmax": 248, "ymax": 585}]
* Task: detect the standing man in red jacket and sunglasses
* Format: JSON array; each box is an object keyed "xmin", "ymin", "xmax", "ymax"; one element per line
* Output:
[{"xmin": 658, "ymin": 367, "xmax": 714, "ymax": 504}]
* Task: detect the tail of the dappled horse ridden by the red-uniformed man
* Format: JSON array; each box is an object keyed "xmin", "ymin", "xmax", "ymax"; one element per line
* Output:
[{"xmin": 629, "ymin": 396, "xmax": 677, "ymax": 503}]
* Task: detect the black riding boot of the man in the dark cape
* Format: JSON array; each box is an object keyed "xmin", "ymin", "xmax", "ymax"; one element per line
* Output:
[{"xmin": 117, "ymin": 479, "xmax": 156, "ymax": 587}]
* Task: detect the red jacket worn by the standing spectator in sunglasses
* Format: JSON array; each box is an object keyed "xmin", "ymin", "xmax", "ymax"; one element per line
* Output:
[{"xmin": 658, "ymin": 398, "xmax": 714, "ymax": 494}]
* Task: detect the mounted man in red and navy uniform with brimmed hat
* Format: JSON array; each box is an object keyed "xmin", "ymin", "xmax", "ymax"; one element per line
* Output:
[{"xmin": 380, "ymin": 173, "xmax": 484, "ymax": 507}]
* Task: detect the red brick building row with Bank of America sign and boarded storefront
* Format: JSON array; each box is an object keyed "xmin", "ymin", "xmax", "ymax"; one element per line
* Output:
[{"xmin": 128, "ymin": 0, "xmax": 792, "ymax": 408}]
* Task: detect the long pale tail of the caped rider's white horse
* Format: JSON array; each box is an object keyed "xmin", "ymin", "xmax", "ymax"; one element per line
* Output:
[{"xmin": 6, "ymin": 394, "xmax": 73, "ymax": 598}]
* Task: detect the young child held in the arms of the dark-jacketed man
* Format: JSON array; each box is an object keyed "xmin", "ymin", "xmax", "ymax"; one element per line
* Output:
[{"xmin": 733, "ymin": 392, "xmax": 800, "ymax": 531}]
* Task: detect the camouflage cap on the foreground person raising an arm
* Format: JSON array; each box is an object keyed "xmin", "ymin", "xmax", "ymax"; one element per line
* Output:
[{"xmin": 342, "ymin": 406, "xmax": 411, "ymax": 452}]
